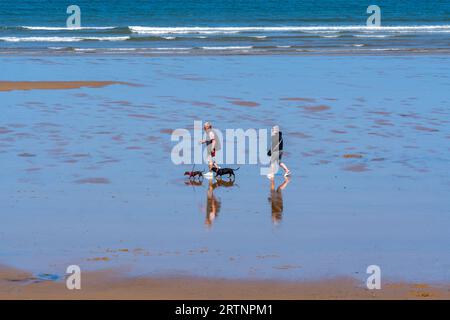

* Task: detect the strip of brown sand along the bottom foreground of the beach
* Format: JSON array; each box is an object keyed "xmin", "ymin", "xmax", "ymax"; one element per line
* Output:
[{"xmin": 0, "ymin": 267, "xmax": 450, "ymax": 300}]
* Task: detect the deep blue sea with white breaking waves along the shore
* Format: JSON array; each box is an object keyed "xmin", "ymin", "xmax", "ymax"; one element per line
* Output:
[{"xmin": 0, "ymin": 0, "xmax": 450, "ymax": 55}]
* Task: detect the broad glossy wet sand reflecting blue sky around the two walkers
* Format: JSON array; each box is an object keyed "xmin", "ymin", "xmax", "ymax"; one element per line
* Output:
[{"xmin": 0, "ymin": 57, "xmax": 450, "ymax": 290}]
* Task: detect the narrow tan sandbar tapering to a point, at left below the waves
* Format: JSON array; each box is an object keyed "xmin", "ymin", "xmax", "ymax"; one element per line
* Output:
[{"xmin": 0, "ymin": 81, "xmax": 125, "ymax": 91}]
